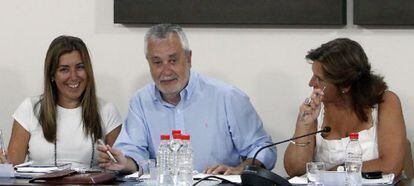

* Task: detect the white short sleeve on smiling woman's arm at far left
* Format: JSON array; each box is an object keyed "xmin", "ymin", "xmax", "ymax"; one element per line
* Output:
[{"xmin": 13, "ymin": 98, "xmax": 38, "ymax": 133}]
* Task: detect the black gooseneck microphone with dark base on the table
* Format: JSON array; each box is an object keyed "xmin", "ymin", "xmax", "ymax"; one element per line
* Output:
[{"xmin": 241, "ymin": 127, "xmax": 331, "ymax": 186}]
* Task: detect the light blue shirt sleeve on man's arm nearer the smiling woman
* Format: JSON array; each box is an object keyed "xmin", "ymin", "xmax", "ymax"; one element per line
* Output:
[{"xmin": 114, "ymin": 96, "xmax": 149, "ymax": 163}]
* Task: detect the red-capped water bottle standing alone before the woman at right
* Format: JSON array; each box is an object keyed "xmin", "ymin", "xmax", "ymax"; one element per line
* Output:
[{"xmin": 345, "ymin": 133, "xmax": 362, "ymax": 186}]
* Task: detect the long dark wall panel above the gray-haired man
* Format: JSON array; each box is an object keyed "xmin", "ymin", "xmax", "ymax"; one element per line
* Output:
[{"xmin": 114, "ymin": 0, "xmax": 346, "ymax": 25}]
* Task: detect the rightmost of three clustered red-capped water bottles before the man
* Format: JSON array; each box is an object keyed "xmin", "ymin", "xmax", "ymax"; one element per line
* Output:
[{"xmin": 178, "ymin": 134, "xmax": 193, "ymax": 186}]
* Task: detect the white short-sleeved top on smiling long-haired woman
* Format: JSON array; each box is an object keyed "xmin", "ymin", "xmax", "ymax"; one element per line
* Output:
[{"xmin": 13, "ymin": 96, "xmax": 122, "ymax": 168}]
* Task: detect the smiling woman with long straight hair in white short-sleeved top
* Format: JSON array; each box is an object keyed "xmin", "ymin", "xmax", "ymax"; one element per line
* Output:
[{"xmin": 0, "ymin": 36, "xmax": 122, "ymax": 168}]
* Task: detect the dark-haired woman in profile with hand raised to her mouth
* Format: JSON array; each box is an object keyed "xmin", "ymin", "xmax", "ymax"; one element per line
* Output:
[{"xmin": 284, "ymin": 38, "xmax": 406, "ymax": 176}]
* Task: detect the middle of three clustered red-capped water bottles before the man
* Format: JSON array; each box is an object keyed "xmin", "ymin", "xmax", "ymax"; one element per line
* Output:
[{"xmin": 170, "ymin": 131, "xmax": 182, "ymax": 185}]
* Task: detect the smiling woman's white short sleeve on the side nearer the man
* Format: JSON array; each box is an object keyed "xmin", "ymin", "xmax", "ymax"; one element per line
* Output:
[{"xmin": 101, "ymin": 103, "xmax": 122, "ymax": 135}]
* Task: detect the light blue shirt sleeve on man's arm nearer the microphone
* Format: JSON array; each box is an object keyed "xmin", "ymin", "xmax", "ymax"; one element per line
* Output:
[{"xmin": 225, "ymin": 87, "xmax": 277, "ymax": 170}]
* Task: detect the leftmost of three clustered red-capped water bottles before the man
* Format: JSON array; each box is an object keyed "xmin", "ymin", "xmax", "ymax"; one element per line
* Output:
[{"xmin": 157, "ymin": 134, "xmax": 173, "ymax": 186}]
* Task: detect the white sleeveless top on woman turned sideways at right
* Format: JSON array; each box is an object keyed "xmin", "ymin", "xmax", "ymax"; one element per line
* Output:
[{"xmin": 314, "ymin": 105, "xmax": 378, "ymax": 170}]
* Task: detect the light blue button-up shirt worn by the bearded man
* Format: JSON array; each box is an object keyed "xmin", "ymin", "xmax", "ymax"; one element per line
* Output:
[{"xmin": 115, "ymin": 71, "xmax": 276, "ymax": 171}]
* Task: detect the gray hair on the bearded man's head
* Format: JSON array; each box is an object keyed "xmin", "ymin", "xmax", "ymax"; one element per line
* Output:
[{"xmin": 144, "ymin": 23, "xmax": 191, "ymax": 56}]
